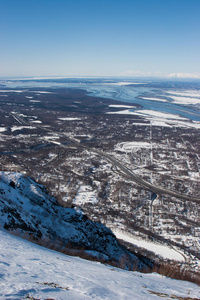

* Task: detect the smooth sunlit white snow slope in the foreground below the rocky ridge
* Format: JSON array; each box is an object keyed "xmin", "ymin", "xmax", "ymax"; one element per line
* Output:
[{"xmin": 0, "ymin": 231, "xmax": 200, "ymax": 300}]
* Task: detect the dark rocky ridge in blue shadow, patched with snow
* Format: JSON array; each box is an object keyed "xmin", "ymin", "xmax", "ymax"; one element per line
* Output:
[{"xmin": 0, "ymin": 172, "xmax": 145, "ymax": 269}]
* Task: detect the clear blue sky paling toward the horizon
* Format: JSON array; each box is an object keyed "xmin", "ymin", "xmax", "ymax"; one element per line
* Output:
[{"xmin": 0, "ymin": 0, "xmax": 200, "ymax": 77}]
